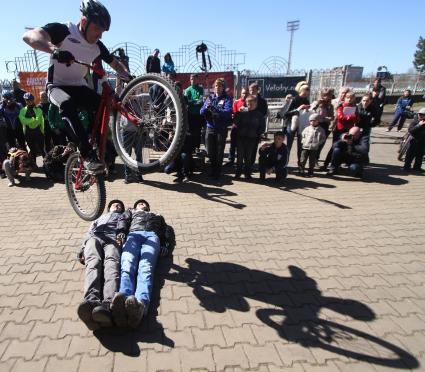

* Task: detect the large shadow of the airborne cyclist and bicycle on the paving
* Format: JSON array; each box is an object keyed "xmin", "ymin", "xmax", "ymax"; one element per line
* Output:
[{"xmin": 166, "ymin": 258, "xmax": 419, "ymax": 369}]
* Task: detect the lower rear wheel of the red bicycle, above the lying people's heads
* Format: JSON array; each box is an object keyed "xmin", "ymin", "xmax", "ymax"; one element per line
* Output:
[{"xmin": 65, "ymin": 152, "xmax": 106, "ymax": 221}]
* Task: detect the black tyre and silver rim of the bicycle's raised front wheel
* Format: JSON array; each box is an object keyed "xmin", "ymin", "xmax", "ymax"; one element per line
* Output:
[{"xmin": 112, "ymin": 74, "xmax": 188, "ymax": 173}]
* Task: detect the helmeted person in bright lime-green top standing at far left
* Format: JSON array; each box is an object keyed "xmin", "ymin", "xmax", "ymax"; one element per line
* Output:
[{"xmin": 19, "ymin": 92, "xmax": 45, "ymax": 167}]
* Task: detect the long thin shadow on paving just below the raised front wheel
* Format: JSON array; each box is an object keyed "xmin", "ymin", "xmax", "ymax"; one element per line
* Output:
[{"xmin": 143, "ymin": 180, "xmax": 246, "ymax": 209}]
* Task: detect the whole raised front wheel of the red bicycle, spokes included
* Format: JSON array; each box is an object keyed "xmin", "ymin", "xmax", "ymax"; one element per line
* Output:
[{"xmin": 112, "ymin": 74, "xmax": 187, "ymax": 172}]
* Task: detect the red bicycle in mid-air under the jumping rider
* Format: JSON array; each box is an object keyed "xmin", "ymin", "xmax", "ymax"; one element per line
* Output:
[{"xmin": 65, "ymin": 61, "xmax": 187, "ymax": 221}]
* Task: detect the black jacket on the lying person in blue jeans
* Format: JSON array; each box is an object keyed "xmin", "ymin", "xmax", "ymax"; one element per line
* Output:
[{"xmin": 117, "ymin": 208, "xmax": 167, "ymax": 245}]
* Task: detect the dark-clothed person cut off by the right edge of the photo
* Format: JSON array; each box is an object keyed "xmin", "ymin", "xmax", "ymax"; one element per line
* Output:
[{"xmin": 403, "ymin": 108, "xmax": 425, "ymax": 172}]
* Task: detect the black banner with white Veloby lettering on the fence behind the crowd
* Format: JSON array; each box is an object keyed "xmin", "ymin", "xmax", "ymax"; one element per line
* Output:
[{"xmin": 248, "ymin": 75, "xmax": 305, "ymax": 98}]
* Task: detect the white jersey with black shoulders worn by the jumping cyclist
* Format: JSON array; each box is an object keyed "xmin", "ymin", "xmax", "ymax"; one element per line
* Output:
[{"xmin": 42, "ymin": 22, "xmax": 113, "ymax": 86}]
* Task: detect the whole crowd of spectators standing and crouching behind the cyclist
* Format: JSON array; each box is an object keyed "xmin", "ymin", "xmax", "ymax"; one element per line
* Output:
[{"xmin": 0, "ymin": 67, "xmax": 423, "ymax": 186}]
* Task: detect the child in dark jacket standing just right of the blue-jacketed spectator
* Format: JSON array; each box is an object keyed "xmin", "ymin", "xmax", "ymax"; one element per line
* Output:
[{"xmin": 235, "ymin": 95, "xmax": 266, "ymax": 179}]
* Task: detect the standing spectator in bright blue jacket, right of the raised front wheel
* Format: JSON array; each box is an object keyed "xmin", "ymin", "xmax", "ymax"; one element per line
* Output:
[{"xmin": 200, "ymin": 78, "xmax": 233, "ymax": 179}]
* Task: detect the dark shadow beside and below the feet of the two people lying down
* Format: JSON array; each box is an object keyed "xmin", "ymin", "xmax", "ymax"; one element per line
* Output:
[{"xmin": 93, "ymin": 244, "xmax": 174, "ymax": 357}]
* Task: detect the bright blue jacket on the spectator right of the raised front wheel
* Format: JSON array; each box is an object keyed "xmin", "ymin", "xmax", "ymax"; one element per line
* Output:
[{"xmin": 200, "ymin": 93, "xmax": 233, "ymax": 129}]
